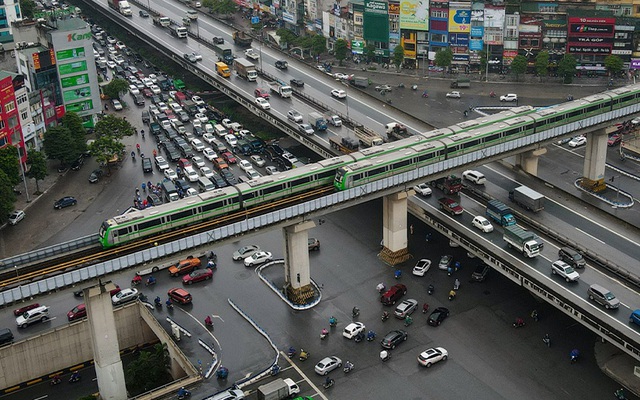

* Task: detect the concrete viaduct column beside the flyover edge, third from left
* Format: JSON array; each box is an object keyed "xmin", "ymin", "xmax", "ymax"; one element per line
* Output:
[{"xmin": 380, "ymin": 191, "xmax": 413, "ymax": 265}]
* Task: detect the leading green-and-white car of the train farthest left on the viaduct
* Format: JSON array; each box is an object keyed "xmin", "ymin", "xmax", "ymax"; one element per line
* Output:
[{"xmin": 99, "ymin": 186, "xmax": 241, "ymax": 248}]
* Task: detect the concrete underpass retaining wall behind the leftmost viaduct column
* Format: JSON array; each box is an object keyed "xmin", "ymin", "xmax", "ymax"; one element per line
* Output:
[{"xmin": 0, "ymin": 303, "xmax": 157, "ymax": 388}]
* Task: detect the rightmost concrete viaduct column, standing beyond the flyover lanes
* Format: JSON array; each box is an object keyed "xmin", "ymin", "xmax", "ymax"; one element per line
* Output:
[{"xmin": 580, "ymin": 127, "xmax": 617, "ymax": 192}]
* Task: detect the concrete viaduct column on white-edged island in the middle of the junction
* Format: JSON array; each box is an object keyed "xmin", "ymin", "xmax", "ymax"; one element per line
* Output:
[{"xmin": 282, "ymin": 221, "xmax": 316, "ymax": 304}]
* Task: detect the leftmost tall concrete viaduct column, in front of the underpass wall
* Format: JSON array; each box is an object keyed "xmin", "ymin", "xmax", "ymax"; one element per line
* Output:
[{"xmin": 84, "ymin": 283, "xmax": 127, "ymax": 400}]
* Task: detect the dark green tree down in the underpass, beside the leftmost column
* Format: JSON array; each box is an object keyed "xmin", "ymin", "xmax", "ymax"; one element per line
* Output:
[{"xmin": 125, "ymin": 343, "xmax": 172, "ymax": 396}]
